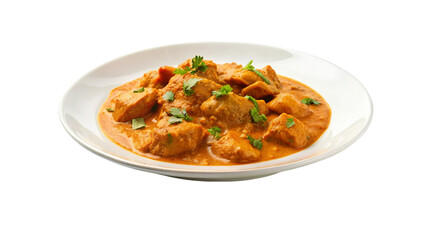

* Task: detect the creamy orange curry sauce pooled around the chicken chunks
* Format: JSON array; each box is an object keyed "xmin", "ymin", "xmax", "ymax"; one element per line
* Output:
[{"xmin": 98, "ymin": 62, "xmax": 331, "ymax": 166}]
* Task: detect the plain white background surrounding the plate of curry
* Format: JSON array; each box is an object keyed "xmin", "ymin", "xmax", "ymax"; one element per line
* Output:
[{"xmin": 0, "ymin": 0, "xmax": 426, "ymax": 240}]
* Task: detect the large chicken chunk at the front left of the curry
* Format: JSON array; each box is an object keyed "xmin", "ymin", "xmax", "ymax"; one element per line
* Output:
[{"xmin": 149, "ymin": 117, "xmax": 207, "ymax": 157}]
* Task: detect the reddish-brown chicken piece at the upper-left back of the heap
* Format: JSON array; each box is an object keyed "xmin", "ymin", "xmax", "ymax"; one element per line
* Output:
[{"xmin": 139, "ymin": 66, "xmax": 176, "ymax": 88}]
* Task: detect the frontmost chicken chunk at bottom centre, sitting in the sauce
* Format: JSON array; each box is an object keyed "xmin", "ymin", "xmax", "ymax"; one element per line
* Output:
[{"xmin": 211, "ymin": 131, "xmax": 260, "ymax": 163}]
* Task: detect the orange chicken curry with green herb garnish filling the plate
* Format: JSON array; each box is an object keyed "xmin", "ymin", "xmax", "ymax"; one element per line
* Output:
[{"xmin": 98, "ymin": 56, "xmax": 331, "ymax": 165}]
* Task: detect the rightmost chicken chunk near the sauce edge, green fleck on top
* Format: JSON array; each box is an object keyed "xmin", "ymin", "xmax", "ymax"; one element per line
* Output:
[{"xmin": 263, "ymin": 113, "xmax": 309, "ymax": 148}]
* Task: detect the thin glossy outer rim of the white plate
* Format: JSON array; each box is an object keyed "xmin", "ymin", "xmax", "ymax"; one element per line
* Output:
[{"xmin": 58, "ymin": 41, "xmax": 374, "ymax": 177}]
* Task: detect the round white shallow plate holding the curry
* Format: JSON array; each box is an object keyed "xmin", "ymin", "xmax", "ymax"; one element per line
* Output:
[{"xmin": 59, "ymin": 43, "xmax": 373, "ymax": 180}]
